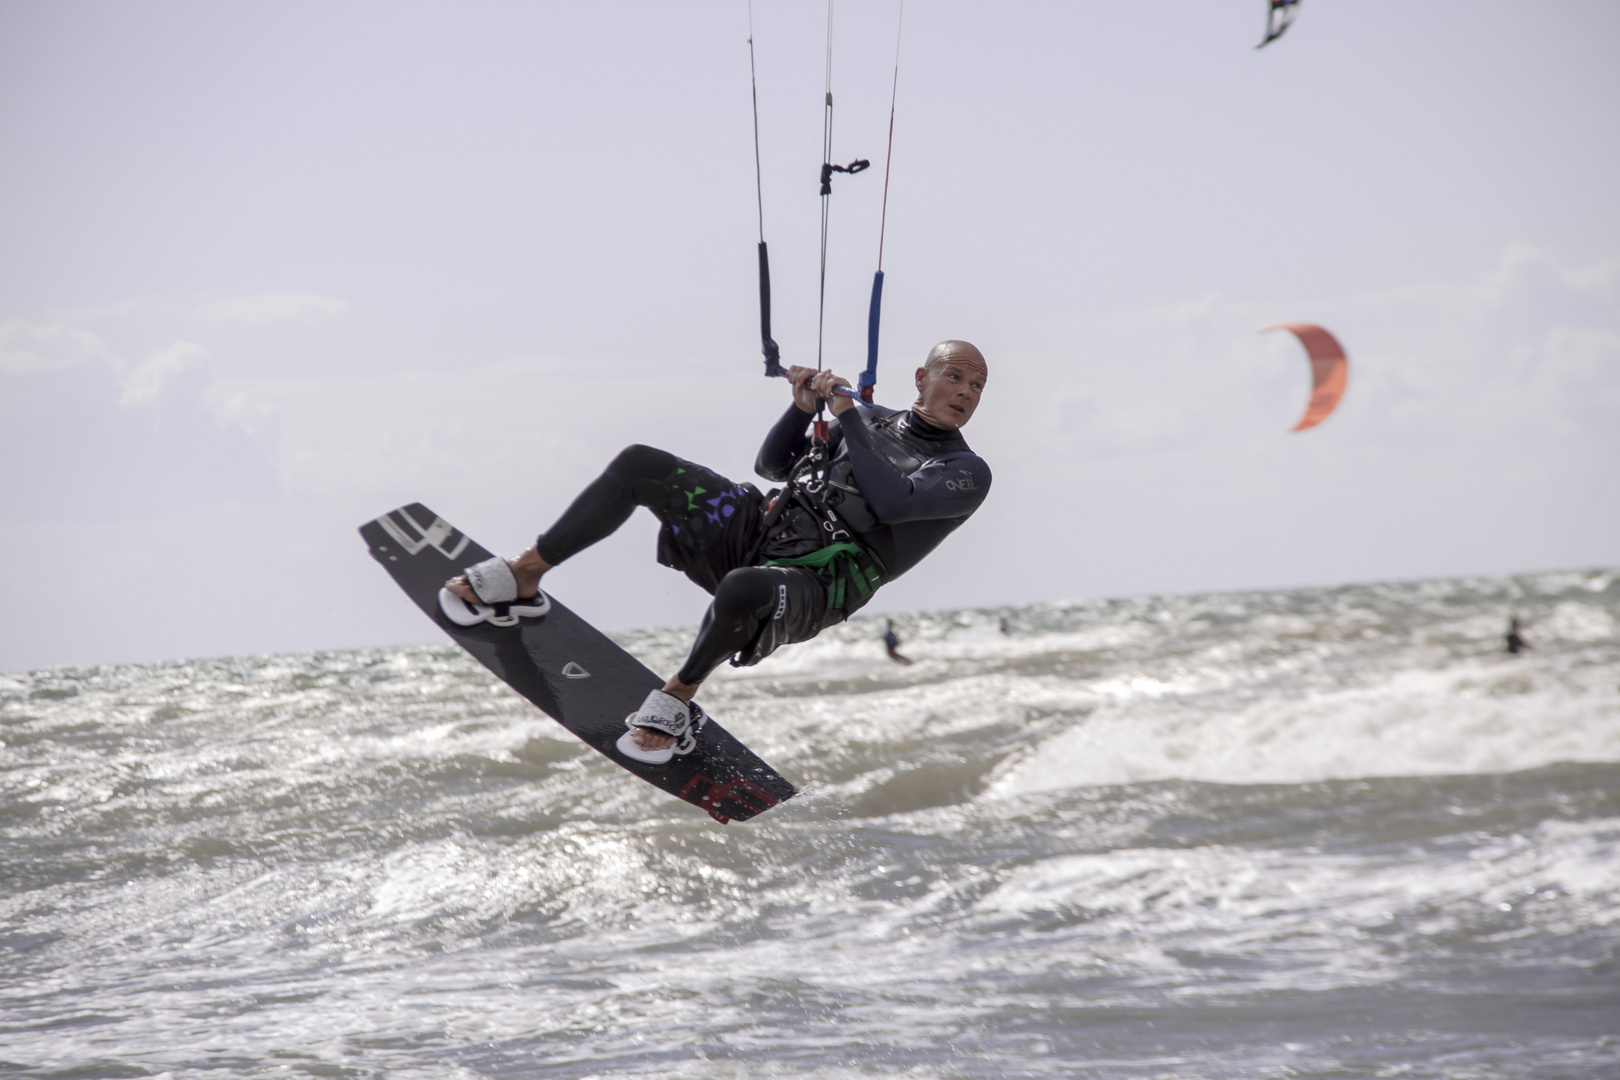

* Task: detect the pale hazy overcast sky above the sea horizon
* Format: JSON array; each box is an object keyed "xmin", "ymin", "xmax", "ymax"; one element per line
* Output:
[{"xmin": 0, "ymin": 0, "xmax": 1620, "ymax": 670}]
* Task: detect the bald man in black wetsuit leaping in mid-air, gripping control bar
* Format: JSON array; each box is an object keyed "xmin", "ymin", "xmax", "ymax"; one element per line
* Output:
[{"xmin": 446, "ymin": 342, "xmax": 990, "ymax": 764}]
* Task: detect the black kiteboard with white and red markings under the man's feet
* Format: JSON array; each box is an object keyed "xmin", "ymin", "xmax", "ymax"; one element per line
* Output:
[{"xmin": 360, "ymin": 502, "xmax": 799, "ymax": 824}]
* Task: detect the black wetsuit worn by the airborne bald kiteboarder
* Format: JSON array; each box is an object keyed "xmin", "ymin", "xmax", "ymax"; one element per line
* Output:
[{"xmin": 535, "ymin": 405, "xmax": 990, "ymax": 685}]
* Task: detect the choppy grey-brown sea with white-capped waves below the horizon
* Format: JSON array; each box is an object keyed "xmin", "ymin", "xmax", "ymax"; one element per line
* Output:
[{"xmin": 0, "ymin": 572, "xmax": 1620, "ymax": 1080}]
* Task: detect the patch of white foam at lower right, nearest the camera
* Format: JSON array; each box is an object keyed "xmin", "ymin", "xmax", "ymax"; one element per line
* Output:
[{"xmin": 974, "ymin": 819, "xmax": 1620, "ymax": 989}]
